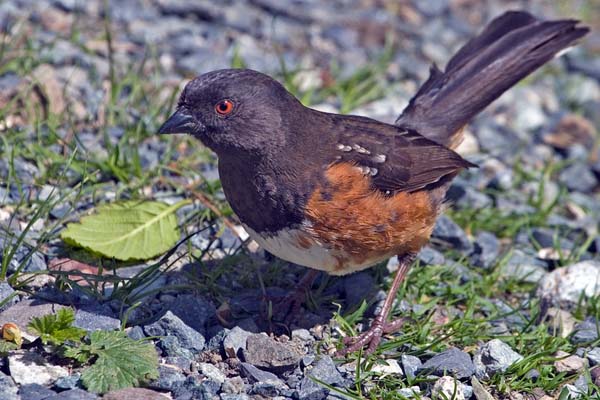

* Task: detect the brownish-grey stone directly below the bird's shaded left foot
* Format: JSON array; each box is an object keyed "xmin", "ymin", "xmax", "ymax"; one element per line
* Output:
[{"xmin": 242, "ymin": 334, "xmax": 303, "ymax": 371}]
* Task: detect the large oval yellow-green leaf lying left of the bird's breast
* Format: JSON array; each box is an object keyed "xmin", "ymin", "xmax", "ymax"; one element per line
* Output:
[{"xmin": 61, "ymin": 200, "xmax": 190, "ymax": 261}]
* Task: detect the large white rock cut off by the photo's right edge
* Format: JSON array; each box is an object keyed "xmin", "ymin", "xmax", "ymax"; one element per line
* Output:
[{"xmin": 537, "ymin": 260, "xmax": 600, "ymax": 305}]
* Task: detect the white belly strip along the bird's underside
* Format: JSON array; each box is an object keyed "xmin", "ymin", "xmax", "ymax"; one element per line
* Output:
[{"xmin": 242, "ymin": 224, "xmax": 394, "ymax": 275}]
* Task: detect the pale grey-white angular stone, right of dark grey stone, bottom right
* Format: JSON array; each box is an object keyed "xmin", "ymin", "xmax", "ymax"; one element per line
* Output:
[{"xmin": 473, "ymin": 339, "xmax": 523, "ymax": 379}]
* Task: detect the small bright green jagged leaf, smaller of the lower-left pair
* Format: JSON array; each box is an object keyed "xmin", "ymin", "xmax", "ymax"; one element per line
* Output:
[{"xmin": 28, "ymin": 308, "xmax": 87, "ymax": 345}]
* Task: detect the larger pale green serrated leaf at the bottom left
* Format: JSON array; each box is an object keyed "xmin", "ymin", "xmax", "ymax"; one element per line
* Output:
[{"xmin": 79, "ymin": 331, "xmax": 158, "ymax": 393}]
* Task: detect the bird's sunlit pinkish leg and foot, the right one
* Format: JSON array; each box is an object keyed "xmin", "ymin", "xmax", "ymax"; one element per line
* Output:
[{"xmin": 336, "ymin": 253, "xmax": 415, "ymax": 356}]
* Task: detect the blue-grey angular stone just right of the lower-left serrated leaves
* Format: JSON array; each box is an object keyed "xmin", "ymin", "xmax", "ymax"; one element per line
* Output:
[{"xmin": 144, "ymin": 311, "xmax": 205, "ymax": 355}]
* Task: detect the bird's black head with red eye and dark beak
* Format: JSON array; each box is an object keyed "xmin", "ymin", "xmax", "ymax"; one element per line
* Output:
[{"xmin": 159, "ymin": 69, "xmax": 302, "ymax": 156}]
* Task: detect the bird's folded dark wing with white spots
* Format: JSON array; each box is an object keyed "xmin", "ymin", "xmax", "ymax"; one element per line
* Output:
[{"xmin": 333, "ymin": 116, "xmax": 476, "ymax": 193}]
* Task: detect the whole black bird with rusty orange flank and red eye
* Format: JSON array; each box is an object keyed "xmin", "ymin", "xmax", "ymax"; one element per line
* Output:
[{"xmin": 158, "ymin": 11, "xmax": 589, "ymax": 355}]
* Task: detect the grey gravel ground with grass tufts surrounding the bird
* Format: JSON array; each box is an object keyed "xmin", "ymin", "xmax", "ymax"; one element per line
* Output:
[{"xmin": 0, "ymin": 0, "xmax": 600, "ymax": 400}]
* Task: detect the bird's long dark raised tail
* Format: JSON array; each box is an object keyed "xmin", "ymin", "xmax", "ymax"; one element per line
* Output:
[{"xmin": 396, "ymin": 11, "xmax": 589, "ymax": 147}]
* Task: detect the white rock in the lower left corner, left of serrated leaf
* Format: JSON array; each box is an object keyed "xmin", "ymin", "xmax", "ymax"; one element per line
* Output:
[{"xmin": 8, "ymin": 351, "xmax": 69, "ymax": 386}]
